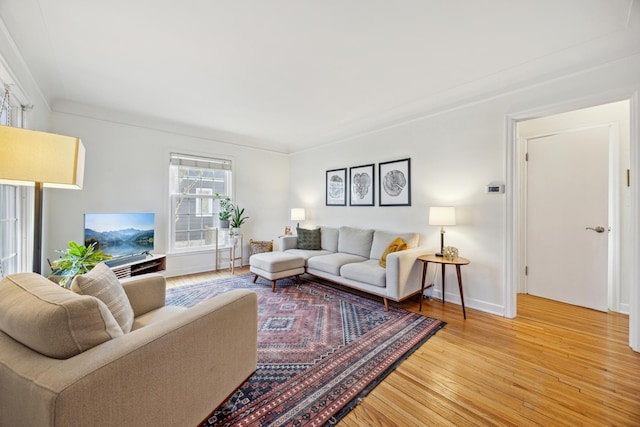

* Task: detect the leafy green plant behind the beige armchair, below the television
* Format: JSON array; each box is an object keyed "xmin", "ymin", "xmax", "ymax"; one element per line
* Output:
[{"xmin": 49, "ymin": 240, "xmax": 112, "ymax": 288}]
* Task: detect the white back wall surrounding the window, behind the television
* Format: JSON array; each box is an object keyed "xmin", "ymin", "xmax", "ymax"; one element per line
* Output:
[{"xmin": 43, "ymin": 113, "xmax": 289, "ymax": 276}]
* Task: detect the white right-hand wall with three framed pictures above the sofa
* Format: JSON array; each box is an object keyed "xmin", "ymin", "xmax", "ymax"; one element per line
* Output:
[{"xmin": 290, "ymin": 56, "xmax": 640, "ymax": 320}]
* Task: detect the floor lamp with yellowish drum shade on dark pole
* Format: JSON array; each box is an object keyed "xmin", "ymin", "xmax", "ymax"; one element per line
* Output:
[{"xmin": 0, "ymin": 126, "xmax": 84, "ymax": 274}]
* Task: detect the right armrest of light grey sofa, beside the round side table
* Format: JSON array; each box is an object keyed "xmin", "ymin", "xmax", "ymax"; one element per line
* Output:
[{"xmin": 387, "ymin": 247, "xmax": 429, "ymax": 300}]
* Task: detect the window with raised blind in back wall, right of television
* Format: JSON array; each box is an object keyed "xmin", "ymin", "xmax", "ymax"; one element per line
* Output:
[{"xmin": 169, "ymin": 153, "xmax": 232, "ymax": 252}]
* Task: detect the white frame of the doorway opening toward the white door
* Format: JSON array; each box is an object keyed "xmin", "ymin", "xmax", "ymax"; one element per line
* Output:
[{"xmin": 504, "ymin": 89, "xmax": 640, "ymax": 351}]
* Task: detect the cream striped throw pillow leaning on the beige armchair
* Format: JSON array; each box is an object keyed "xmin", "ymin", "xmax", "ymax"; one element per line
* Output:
[{"xmin": 71, "ymin": 262, "xmax": 133, "ymax": 334}]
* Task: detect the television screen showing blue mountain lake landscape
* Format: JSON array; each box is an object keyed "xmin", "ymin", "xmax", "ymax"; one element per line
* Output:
[{"xmin": 84, "ymin": 213, "xmax": 155, "ymax": 257}]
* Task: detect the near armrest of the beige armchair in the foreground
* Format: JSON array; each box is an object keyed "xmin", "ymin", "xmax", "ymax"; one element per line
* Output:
[{"xmin": 0, "ymin": 289, "xmax": 258, "ymax": 426}]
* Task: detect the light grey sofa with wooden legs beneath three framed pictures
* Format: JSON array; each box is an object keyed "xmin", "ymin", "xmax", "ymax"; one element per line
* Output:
[{"xmin": 280, "ymin": 226, "xmax": 428, "ymax": 310}]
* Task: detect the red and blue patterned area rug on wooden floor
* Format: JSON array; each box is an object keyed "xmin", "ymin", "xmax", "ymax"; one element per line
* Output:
[{"xmin": 167, "ymin": 274, "xmax": 445, "ymax": 426}]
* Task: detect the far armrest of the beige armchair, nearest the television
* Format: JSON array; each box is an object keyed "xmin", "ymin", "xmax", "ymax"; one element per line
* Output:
[{"xmin": 120, "ymin": 273, "xmax": 167, "ymax": 317}]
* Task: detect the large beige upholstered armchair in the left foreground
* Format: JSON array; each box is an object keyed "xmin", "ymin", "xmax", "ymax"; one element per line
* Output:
[{"xmin": 0, "ymin": 273, "xmax": 257, "ymax": 427}]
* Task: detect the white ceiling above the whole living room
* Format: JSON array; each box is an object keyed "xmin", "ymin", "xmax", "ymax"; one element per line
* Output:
[{"xmin": 0, "ymin": 0, "xmax": 640, "ymax": 153}]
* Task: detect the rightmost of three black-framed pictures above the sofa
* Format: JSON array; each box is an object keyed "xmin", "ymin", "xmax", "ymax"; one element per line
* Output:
[{"xmin": 378, "ymin": 159, "xmax": 411, "ymax": 206}]
